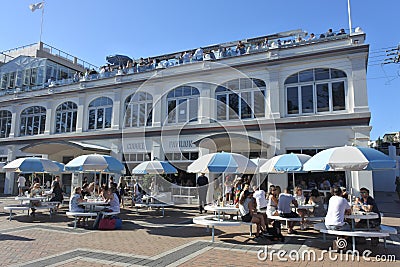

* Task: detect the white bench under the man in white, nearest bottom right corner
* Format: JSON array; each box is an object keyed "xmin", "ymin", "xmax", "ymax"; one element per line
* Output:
[{"xmin": 314, "ymin": 223, "xmax": 390, "ymax": 251}]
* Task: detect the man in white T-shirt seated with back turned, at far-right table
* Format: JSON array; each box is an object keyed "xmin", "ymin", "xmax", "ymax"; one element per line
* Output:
[{"xmin": 325, "ymin": 187, "xmax": 351, "ymax": 231}]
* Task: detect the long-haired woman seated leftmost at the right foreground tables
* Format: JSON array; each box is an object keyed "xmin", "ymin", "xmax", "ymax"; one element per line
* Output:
[{"xmin": 239, "ymin": 190, "xmax": 266, "ymax": 241}]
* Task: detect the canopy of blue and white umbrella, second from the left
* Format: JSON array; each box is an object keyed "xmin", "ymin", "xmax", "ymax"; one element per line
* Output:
[{"xmin": 65, "ymin": 154, "xmax": 125, "ymax": 174}]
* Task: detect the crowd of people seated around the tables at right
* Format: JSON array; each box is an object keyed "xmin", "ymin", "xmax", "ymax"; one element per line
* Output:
[{"xmin": 202, "ymin": 174, "xmax": 381, "ymax": 245}]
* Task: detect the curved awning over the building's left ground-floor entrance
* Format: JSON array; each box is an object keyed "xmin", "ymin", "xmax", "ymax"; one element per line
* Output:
[{"xmin": 21, "ymin": 141, "xmax": 111, "ymax": 155}]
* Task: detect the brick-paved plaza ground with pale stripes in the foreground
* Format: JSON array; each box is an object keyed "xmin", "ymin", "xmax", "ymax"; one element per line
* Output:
[{"xmin": 0, "ymin": 193, "xmax": 400, "ymax": 267}]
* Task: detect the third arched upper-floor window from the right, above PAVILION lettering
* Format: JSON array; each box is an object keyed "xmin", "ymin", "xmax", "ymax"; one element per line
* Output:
[{"xmin": 167, "ymin": 86, "xmax": 200, "ymax": 123}]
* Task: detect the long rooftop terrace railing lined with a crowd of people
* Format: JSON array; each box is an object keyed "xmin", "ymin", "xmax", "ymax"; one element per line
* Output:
[{"xmin": 0, "ymin": 27, "xmax": 360, "ymax": 98}]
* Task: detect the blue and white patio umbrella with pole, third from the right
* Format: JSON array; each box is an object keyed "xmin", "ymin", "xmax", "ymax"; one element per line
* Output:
[{"xmin": 187, "ymin": 152, "xmax": 257, "ymax": 195}]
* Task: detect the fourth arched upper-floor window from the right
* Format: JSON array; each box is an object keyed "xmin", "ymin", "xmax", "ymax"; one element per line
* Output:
[{"xmin": 124, "ymin": 92, "xmax": 153, "ymax": 128}]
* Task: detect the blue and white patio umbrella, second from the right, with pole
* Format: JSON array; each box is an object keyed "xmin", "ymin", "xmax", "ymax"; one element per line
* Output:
[{"xmin": 260, "ymin": 153, "xmax": 311, "ymax": 188}]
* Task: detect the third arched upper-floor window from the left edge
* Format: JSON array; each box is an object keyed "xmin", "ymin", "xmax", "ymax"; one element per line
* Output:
[{"xmin": 56, "ymin": 101, "xmax": 78, "ymax": 133}]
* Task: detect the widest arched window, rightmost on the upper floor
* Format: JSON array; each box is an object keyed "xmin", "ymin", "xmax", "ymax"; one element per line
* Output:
[{"xmin": 285, "ymin": 68, "xmax": 347, "ymax": 115}]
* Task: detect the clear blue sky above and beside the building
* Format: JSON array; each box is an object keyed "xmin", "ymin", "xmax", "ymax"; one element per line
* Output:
[{"xmin": 0, "ymin": 0, "xmax": 400, "ymax": 140}]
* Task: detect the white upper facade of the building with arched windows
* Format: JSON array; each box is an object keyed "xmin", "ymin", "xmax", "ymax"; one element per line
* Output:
[{"xmin": 0, "ymin": 29, "xmax": 371, "ymax": 193}]
